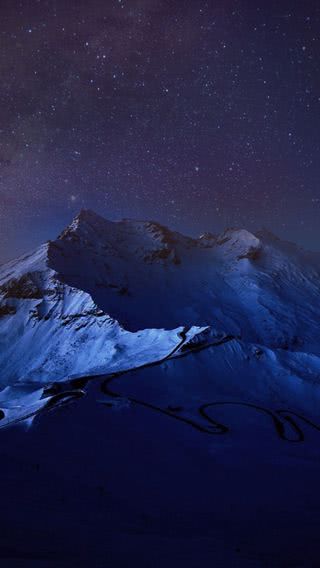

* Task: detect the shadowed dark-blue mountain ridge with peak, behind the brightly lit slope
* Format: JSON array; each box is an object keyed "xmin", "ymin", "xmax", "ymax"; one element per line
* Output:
[{"xmin": 48, "ymin": 211, "xmax": 320, "ymax": 353}]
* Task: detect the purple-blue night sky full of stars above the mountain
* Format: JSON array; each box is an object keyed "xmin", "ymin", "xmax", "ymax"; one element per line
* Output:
[{"xmin": 0, "ymin": 0, "xmax": 320, "ymax": 262}]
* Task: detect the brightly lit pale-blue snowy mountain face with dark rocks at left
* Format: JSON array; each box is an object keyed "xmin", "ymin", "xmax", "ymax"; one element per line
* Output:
[{"xmin": 0, "ymin": 237, "xmax": 203, "ymax": 384}]
